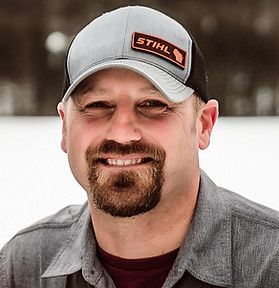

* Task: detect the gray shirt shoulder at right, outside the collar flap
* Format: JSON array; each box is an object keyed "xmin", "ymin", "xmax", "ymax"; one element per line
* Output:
[{"xmin": 218, "ymin": 188, "xmax": 279, "ymax": 287}]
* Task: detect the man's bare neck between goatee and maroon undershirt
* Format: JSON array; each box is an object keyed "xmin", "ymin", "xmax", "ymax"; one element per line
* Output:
[{"xmin": 89, "ymin": 171, "xmax": 199, "ymax": 259}]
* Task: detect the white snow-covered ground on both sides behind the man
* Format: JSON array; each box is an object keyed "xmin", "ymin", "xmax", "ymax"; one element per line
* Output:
[{"xmin": 0, "ymin": 117, "xmax": 279, "ymax": 247}]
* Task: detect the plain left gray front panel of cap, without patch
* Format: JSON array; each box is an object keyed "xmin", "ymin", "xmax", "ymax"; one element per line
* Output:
[{"xmin": 67, "ymin": 9, "xmax": 128, "ymax": 83}]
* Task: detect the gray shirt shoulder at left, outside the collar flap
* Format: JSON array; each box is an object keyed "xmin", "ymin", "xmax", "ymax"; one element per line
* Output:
[{"xmin": 0, "ymin": 205, "xmax": 86, "ymax": 287}]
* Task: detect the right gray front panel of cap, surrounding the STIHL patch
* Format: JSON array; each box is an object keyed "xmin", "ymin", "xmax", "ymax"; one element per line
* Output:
[{"xmin": 124, "ymin": 7, "xmax": 192, "ymax": 82}]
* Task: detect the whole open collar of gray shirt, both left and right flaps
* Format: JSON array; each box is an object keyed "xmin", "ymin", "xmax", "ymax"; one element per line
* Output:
[{"xmin": 42, "ymin": 171, "xmax": 232, "ymax": 287}]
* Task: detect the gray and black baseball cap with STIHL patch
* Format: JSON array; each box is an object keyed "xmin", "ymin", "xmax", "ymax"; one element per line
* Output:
[{"xmin": 62, "ymin": 6, "xmax": 208, "ymax": 103}]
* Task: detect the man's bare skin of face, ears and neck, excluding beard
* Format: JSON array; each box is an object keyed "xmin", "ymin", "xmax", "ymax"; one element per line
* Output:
[{"xmin": 58, "ymin": 69, "xmax": 218, "ymax": 259}]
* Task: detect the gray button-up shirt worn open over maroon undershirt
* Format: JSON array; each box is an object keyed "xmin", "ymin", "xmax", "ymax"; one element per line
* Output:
[{"xmin": 0, "ymin": 172, "xmax": 279, "ymax": 288}]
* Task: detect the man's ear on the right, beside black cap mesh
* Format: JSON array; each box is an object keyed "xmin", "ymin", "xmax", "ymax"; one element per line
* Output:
[{"xmin": 199, "ymin": 99, "xmax": 219, "ymax": 150}]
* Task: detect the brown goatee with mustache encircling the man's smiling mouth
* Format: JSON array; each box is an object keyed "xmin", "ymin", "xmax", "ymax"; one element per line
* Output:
[{"xmin": 86, "ymin": 140, "xmax": 165, "ymax": 217}]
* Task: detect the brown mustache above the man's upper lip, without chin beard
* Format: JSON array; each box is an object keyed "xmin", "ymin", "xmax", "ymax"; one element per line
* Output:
[{"xmin": 86, "ymin": 140, "xmax": 166, "ymax": 163}]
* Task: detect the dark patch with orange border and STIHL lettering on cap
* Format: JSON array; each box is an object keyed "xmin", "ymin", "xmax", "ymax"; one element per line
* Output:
[{"xmin": 132, "ymin": 32, "xmax": 187, "ymax": 69}]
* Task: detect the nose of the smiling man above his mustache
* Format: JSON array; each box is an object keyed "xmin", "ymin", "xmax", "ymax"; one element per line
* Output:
[{"xmin": 107, "ymin": 109, "xmax": 142, "ymax": 144}]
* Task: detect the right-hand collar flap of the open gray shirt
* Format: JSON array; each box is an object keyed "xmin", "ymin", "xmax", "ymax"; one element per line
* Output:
[{"xmin": 172, "ymin": 171, "xmax": 232, "ymax": 287}]
